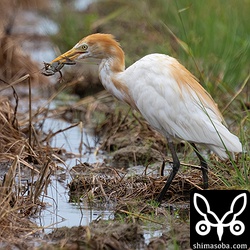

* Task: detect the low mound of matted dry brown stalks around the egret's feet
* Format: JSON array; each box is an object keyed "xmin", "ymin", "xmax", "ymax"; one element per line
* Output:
[{"xmin": 69, "ymin": 165, "xmax": 209, "ymax": 203}]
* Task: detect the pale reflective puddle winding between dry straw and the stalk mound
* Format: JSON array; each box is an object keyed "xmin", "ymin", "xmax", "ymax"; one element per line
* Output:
[{"xmin": 36, "ymin": 119, "xmax": 113, "ymax": 231}]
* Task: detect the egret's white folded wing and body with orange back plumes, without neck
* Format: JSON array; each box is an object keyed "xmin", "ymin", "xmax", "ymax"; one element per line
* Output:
[{"xmin": 118, "ymin": 54, "xmax": 242, "ymax": 158}]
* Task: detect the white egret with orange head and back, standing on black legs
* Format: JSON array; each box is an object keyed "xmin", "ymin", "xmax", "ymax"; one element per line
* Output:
[{"xmin": 46, "ymin": 34, "xmax": 242, "ymax": 202}]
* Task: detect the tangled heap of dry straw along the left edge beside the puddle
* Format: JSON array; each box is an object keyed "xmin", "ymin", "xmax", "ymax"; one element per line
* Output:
[{"xmin": 0, "ymin": 75, "xmax": 55, "ymax": 242}]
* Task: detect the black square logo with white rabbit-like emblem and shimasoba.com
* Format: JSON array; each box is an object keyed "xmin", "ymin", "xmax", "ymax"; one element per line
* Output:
[{"xmin": 190, "ymin": 190, "xmax": 250, "ymax": 249}]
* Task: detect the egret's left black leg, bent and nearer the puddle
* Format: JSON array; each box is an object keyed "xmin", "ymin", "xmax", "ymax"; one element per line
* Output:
[{"xmin": 157, "ymin": 141, "xmax": 180, "ymax": 203}]
